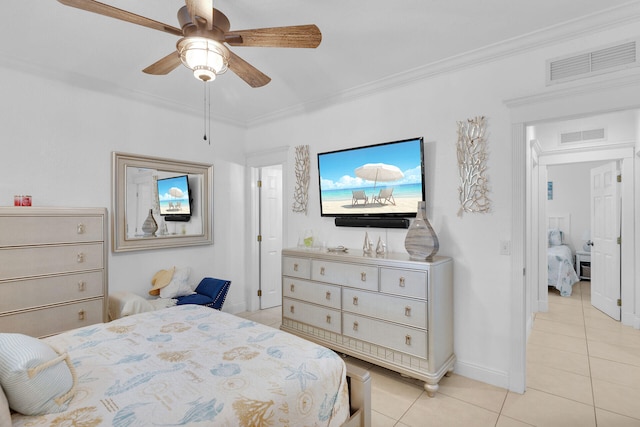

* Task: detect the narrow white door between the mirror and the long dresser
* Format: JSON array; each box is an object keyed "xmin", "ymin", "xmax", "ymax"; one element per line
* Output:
[{"xmin": 259, "ymin": 165, "xmax": 282, "ymax": 309}]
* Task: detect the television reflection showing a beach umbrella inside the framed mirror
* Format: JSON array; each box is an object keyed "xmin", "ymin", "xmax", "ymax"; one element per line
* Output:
[{"xmin": 158, "ymin": 175, "xmax": 191, "ymax": 221}]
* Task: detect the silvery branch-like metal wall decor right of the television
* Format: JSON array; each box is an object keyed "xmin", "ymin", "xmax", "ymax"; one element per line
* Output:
[{"xmin": 457, "ymin": 116, "xmax": 491, "ymax": 216}]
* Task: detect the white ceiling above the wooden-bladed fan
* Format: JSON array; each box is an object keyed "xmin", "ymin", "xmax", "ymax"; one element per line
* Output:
[{"xmin": 0, "ymin": 0, "xmax": 640, "ymax": 124}]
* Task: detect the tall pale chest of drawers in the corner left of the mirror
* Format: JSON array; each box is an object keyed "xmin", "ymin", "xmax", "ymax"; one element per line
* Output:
[{"xmin": 0, "ymin": 207, "xmax": 107, "ymax": 337}]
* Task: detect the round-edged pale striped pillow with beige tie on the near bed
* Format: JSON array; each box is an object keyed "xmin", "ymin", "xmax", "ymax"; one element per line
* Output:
[{"xmin": 0, "ymin": 334, "xmax": 75, "ymax": 416}]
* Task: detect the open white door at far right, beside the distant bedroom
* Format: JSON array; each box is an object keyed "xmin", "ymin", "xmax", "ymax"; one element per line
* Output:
[{"xmin": 591, "ymin": 162, "xmax": 621, "ymax": 320}]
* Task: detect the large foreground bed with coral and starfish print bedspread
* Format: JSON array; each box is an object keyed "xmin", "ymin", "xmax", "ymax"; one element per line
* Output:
[{"xmin": 0, "ymin": 305, "xmax": 370, "ymax": 427}]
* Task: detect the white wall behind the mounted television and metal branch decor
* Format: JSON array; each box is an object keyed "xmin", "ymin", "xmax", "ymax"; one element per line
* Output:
[{"xmin": 247, "ymin": 18, "xmax": 638, "ymax": 387}]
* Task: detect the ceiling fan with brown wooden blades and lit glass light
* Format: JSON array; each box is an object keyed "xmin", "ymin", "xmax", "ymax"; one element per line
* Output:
[{"xmin": 58, "ymin": 0, "xmax": 322, "ymax": 87}]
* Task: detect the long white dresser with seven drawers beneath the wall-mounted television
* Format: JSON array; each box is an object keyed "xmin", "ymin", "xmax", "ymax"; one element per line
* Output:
[{"xmin": 281, "ymin": 249, "xmax": 455, "ymax": 396}]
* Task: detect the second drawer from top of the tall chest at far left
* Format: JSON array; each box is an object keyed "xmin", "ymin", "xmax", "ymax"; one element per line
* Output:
[{"xmin": 0, "ymin": 243, "xmax": 104, "ymax": 280}]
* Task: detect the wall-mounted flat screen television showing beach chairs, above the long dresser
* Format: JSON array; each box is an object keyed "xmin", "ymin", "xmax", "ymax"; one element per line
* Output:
[{"xmin": 318, "ymin": 137, "xmax": 425, "ymax": 219}]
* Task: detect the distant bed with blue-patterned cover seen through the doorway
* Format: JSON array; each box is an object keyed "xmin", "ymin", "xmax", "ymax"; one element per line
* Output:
[{"xmin": 547, "ymin": 216, "xmax": 580, "ymax": 297}]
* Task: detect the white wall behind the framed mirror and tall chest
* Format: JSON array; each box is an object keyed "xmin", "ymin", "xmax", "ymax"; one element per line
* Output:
[{"xmin": 0, "ymin": 68, "xmax": 247, "ymax": 312}]
